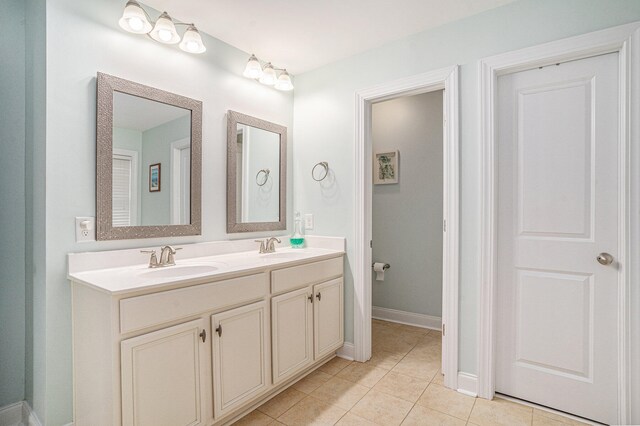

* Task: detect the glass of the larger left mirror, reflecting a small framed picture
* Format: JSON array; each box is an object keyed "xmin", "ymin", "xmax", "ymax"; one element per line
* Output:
[{"xmin": 112, "ymin": 92, "xmax": 191, "ymax": 227}]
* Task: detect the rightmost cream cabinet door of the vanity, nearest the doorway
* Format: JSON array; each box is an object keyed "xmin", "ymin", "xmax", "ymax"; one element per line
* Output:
[{"xmin": 313, "ymin": 278, "xmax": 344, "ymax": 359}]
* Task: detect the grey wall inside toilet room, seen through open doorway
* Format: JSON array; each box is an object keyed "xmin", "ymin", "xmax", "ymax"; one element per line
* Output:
[{"xmin": 371, "ymin": 91, "xmax": 442, "ymax": 317}]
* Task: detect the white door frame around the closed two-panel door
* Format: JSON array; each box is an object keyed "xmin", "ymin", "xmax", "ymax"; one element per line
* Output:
[{"xmin": 478, "ymin": 22, "xmax": 640, "ymax": 424}]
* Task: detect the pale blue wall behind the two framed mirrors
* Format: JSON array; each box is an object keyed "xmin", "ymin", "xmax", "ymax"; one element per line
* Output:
[{"xmin": 43, "ymin": 0, "xmax": 293, "ymax": 426}]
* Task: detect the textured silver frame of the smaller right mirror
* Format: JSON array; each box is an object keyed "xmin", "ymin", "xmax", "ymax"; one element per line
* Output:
[{"xmin": 227, "ymin": 110, "xmax": 287, "ymax": 234}]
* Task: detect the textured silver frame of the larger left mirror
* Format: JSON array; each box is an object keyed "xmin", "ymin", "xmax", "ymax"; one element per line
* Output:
[{"xmin": 96, "ymin": 72, "xmax": 202, "ymax": 241}]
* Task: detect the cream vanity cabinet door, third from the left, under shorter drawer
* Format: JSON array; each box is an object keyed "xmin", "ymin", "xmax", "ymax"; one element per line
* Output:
[{"xmin": 271, "ymin": 287, "xmax": 313, "ymax": 384}]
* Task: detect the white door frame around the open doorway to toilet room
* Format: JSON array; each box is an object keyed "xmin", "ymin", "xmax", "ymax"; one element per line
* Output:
[{"xmin": 353, "ymin": 65, "xmax": 460, "ymax": 389}]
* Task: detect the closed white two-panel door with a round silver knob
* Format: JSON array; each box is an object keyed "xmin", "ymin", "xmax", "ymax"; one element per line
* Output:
[{"xmin": 496, "ymin": 53, "xmax": 618, "ymax": 423}]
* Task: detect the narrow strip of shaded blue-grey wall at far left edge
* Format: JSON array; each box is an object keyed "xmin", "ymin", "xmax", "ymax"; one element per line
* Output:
[{"xmin": 0, "ymin": 0, "xmax": 26, "ymax": 407}]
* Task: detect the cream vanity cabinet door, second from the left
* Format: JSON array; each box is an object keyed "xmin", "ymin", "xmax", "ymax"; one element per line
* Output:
[{"xmin": 211, "ymin": 301, "xmax": 269, "ymax": 418}]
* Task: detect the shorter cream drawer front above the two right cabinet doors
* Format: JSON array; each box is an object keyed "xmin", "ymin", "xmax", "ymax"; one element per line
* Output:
[{"xmin": 271, "ymin": 257, "xmax": 344, "ymax": 294}]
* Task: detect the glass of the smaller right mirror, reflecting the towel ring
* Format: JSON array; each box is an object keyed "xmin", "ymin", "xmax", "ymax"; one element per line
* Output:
[{"xmin": 236, "ymin": 123, "xmax": 280, "ymax": 223}]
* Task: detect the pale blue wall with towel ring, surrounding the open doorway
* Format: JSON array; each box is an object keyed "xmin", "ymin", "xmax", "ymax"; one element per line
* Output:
[{"xmin": 294, "ymin": 0, "xmax": 640, "ymax": 373}]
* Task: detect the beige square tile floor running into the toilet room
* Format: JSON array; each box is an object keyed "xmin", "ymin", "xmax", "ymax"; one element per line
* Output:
[{"xmin": 235, "ymin": 320, "xmax": 582, "ymax": 426}]
